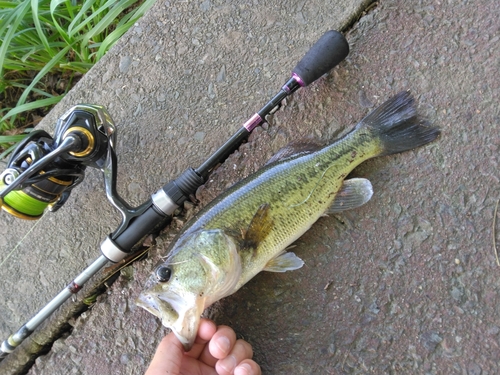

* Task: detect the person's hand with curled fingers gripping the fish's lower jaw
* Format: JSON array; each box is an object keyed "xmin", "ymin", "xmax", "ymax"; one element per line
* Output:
[{"xmin": 146, "ymin": 319, "xmax": 262, "ymax": 375}]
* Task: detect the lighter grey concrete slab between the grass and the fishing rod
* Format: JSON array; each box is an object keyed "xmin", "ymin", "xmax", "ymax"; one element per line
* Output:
[{"xmin": 0, "ymin": 0, "xmax": 370, "ymax": 374}]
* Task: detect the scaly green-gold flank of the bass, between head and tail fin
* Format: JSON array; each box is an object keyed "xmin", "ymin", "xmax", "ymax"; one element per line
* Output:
[{"xmin": 185, "ymin": 131, "xmax": 380, "ymax": 288}]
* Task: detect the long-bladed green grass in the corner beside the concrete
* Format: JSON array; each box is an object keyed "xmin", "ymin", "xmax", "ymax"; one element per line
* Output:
[{"xmin": 0, "ymin": 0, "xmax": 155, "ymax": 159}]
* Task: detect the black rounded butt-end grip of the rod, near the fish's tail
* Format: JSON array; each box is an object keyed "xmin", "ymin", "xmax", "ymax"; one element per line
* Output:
[{"xmin": 292, "ymin": 30, "xmax": 349, "ymax": 86}]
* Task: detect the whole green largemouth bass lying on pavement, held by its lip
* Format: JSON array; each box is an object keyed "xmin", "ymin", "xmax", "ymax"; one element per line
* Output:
[{"xmin": 136, "ymin": 91, "xmax": 440, "ymax": 351}]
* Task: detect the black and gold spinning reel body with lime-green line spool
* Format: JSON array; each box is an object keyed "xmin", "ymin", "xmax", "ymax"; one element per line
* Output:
[{"xmin": 0, "ymin": 105, "xmax": 116, "ymax": 220}]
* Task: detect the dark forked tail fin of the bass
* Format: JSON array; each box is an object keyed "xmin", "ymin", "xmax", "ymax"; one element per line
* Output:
[{"xmin": 356, "ymin": 91, "xmax": 441, "ymax": 155}]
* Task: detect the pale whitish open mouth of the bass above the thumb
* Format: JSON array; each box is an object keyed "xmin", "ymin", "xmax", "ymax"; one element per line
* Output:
[{"xmin": 136, "ymin": 291, "xmax": 205, "ymax": 351}]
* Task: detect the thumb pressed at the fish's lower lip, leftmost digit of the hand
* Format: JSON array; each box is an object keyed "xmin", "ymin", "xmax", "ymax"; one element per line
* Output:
[{"xmin": 146, "ymin": 332, "xmax": 184, "ymax": 375}]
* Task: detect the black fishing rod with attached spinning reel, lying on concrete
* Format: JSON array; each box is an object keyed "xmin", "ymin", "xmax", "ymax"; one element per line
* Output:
[{"xmin": 0, "ymin": 30, "xmax": 349, "ymax": 361}]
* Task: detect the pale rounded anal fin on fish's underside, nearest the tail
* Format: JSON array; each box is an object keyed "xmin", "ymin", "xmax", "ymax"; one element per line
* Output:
[{"xmin": 325, "ymin": 178, "xmax": 373, "ymax": 214}]
